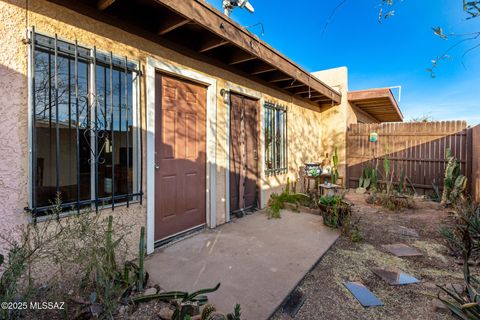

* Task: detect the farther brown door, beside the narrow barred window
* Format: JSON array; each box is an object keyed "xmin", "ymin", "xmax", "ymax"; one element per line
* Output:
[{"xmin": 230, "ymin": 93, "xmax": 258, "ymax": 212}]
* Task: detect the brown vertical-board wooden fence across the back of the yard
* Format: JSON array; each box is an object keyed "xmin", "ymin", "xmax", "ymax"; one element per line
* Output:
[{"xmin": 347, "ymin": 121, "xmax": 474, "ymax": 194}]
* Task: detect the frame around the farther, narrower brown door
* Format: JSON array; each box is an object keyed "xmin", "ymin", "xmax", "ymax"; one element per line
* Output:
[{"xmin": 225, "ymin": 82, "xmax": 264, "ymax": 222}]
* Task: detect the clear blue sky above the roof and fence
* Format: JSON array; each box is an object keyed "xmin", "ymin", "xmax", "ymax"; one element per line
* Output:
[{"xmin": 208, "ymin": 0, "xmax": 480, "ymax": 124}]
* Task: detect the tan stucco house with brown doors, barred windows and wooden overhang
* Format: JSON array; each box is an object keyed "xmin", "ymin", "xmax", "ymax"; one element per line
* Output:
[{"xmin": 0, "ymin": 0, "xmax": 401, "ymax": 253}]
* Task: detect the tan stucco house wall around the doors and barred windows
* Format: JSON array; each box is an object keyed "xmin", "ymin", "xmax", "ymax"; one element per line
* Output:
[{"xmin": 0, "ymin": 0, "xmax": 348, "ymax": 250}]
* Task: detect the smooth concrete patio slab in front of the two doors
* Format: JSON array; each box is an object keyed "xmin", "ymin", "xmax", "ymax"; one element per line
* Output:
[{"xmin": 145, "ymin": 210, "xmax": 339, "ymax": 320}]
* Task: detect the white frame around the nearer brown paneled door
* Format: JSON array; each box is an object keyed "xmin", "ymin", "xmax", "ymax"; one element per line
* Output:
[{"xmin": 146, "ymin": 57, "xmax": 217, "ymax": 254}]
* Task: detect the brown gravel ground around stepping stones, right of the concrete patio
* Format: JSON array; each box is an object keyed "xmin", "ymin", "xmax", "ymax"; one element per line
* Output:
[{"xmin": 272, "ymin": 192, "xmax": 472, "ymax": 320}]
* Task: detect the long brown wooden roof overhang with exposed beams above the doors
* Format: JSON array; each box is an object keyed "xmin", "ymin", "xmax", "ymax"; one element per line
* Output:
[{"xmin": 46, "ymin": 0, "xmax": 341, "ymax": 106}]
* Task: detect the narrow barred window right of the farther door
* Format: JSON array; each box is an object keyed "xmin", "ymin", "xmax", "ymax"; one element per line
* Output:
[{"xmin": 264, "ymin": 102, "xmax": 288, "ymax": 175}]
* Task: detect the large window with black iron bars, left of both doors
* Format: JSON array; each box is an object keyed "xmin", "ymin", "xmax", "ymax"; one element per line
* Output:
[{"xmin": 27, "ymin": 28, "xmax": 142, "ymax": 218}]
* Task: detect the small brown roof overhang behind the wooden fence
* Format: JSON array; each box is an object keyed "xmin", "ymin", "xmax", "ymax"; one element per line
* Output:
[{"xmin": 348, "ymin": 88, "xmax": 403, "ymax": 122}]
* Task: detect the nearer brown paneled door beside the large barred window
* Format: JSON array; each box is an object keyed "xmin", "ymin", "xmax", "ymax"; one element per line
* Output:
[{"xmin": 155, "ymin": 73, "xmax": 207, "ymax": 240}]
